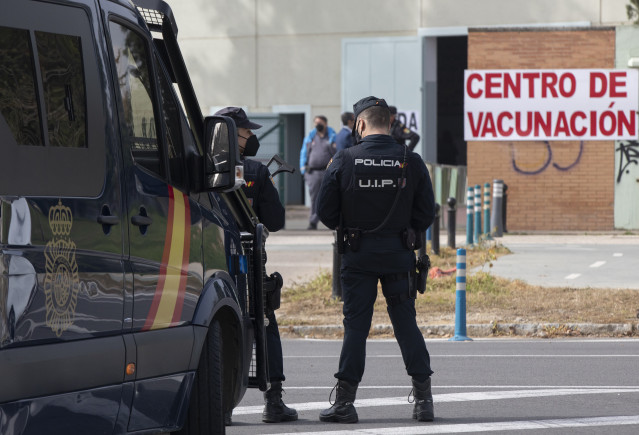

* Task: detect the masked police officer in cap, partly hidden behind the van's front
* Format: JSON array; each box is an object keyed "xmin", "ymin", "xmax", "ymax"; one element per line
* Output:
[{"xmin": 216, "ymin": 107, "xmax": 297, "ymax": 424}]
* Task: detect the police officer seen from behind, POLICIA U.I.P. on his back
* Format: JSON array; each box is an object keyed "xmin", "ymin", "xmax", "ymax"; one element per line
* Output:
[{"xmin": 318, "ymin": 97, "xmax": 435, "ymax": 423}]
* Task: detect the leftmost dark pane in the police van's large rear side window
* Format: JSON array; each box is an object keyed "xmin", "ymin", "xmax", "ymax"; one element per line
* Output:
[{"xmin": 0, "ymin": 27, "xmax": 44, "ymax": 145}]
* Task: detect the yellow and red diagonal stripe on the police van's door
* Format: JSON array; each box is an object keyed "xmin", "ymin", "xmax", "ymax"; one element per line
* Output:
[{"xmin": 142, "ymin": 186, "xmax": 191, "ymax": 331}]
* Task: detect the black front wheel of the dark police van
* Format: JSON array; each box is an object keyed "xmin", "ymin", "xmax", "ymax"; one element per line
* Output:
[{"xmin": 174, "ymin": 320, "xmax": 226, "ymax": 435}]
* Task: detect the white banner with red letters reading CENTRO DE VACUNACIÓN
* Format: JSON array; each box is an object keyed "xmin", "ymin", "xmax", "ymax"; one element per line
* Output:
[{"xmin": 464, "ymin": 69, "xmax": 639, "ymax": 141}]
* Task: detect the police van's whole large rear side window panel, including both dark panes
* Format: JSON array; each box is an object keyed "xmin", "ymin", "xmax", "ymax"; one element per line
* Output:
[{"xmin": 0, "ymin": 0, "xmax": 105, "ymax": 197}]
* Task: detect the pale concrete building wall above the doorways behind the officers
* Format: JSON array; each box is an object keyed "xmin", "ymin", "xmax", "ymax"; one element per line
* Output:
[{"xmin": 167, "ymin": 0, "xmax": 627, "ymax": 127}]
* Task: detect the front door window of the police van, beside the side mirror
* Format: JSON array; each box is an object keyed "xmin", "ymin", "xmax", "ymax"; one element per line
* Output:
[{"xmin": 109, "ymin": 22, "xmax": 165, "ymax": 178}]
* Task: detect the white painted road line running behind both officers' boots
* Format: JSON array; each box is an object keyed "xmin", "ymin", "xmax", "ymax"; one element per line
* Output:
[{"xmin": 233, "ymin": 388, "xmax": 639, "ymax": 415}]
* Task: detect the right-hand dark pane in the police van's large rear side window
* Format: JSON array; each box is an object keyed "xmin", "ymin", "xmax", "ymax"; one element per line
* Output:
[{"xmin": 35, "ymin": 32, "xmax": 87, "ymax": 148}]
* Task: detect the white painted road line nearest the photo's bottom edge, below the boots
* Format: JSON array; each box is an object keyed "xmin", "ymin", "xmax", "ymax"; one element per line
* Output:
[{"xmin": 281, "ymin": 415, "xmax": 639, "ymax": 435}]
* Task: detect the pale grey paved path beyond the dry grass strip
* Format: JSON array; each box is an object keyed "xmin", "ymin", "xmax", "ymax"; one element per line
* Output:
[{"xmin": 266, "ymin": 229, "xmax": 639, "ymax": 290}]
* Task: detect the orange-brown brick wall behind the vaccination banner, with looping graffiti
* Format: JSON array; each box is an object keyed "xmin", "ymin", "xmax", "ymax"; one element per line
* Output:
[{"xmin": 467, "ymin": 28, "xmax": 615, "ymax": 231}]
